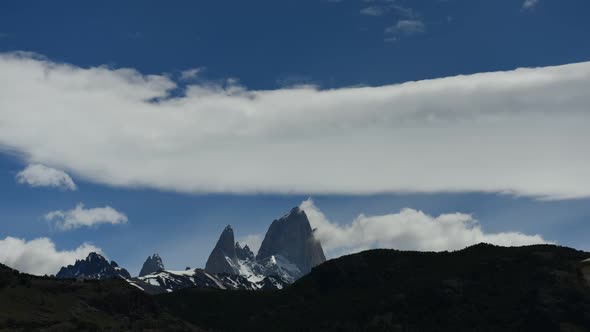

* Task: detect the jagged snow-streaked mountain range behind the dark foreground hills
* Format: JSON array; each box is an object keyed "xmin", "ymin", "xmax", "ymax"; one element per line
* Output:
[{"xmin": 56, "ymin": 207, "xmax": 326, "ymax": 294}]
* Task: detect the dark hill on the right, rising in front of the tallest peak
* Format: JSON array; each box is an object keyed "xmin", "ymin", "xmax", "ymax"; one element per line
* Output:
[{"xmin": 157, "ymin": 244, "xmax": 590, "ymax": 331}]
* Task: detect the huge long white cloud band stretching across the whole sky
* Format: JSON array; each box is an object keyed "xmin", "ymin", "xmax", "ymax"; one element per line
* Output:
[{"xmin": 0, "ymin": 54, "xmax": 590, "ymax": 198}]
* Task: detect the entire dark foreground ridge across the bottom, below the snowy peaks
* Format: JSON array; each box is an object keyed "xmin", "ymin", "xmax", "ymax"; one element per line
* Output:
[{"xmin": 0, "ymin": 244, "xmax": 590, "ymax": 332}]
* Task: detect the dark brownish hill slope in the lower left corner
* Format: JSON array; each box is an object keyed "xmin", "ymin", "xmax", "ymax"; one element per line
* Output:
[{"xmin": 0, "ymin": 264, "xmax": 198, "ymax": 331}]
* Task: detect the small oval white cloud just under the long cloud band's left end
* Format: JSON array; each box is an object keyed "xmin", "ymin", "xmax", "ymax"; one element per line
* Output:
[{"xmin": 16, "ymin": 164, "xmax": 77, "ymax": 190}]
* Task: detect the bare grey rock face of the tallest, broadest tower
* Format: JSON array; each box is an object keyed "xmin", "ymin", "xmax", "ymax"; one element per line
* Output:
[{"xmin": 256, "ymin": 207, "xmax": 326, "ymax": 274}]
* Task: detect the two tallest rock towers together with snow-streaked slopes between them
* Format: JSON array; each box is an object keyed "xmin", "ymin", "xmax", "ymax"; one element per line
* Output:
[{"xmin": 205, "ymin": 207, "xmax": 326, "ymax": 283}]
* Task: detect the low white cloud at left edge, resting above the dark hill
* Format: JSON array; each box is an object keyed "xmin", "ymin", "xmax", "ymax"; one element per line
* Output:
[{"xmin": 0, "ymin": 236, "xmax": 102, "ymax": 275}]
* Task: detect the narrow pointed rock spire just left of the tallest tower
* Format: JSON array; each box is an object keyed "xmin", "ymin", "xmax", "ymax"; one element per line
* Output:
[{"xmin": 205, "ymin": 225, "xmax": 238, "ymax": 274}]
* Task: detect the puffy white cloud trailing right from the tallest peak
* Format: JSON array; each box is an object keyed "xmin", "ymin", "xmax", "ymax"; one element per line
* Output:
[{"xmin": 300, "ymin": 199, "xmax": 547, "ymax": 256}]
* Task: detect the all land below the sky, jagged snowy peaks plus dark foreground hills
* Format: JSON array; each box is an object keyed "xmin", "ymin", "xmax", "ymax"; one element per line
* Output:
[{"xmin": 13, "ymin": 208, "xmax": 590, "ymax": 332}]
